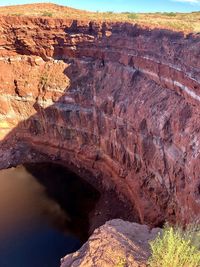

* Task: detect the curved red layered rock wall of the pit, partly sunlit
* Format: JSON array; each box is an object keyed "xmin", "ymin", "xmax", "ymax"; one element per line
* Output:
[{"xmin": 0, "ymin": 17, "xmax": 200, "ymax": 225}]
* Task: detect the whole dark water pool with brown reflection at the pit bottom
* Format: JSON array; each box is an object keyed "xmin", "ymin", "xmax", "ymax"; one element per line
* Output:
[{"xmin": 0, "ymin": 163, "xmax": 98, "ymax": 267}]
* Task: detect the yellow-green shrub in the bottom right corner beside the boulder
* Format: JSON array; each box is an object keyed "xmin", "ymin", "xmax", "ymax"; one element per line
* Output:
[{"xmin": 148, "ymin": 226, "xmax": 200, "ymax": 267}]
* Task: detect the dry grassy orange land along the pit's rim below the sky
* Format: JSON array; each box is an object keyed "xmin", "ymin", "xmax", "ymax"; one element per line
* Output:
[{"xmin": 0, "ymin": 3, "xmax": 200, "ymax": 33}]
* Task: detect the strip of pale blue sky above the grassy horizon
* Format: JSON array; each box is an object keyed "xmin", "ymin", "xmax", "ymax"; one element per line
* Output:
[{"xmin": 0, "ymin": 0, "xmax": 200, "ymax": 12}]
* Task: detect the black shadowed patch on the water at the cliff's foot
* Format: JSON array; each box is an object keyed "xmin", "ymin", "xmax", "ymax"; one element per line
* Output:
[{"xmin": 24, "ymin": 163, "xmax": 100, "ymax": 242}]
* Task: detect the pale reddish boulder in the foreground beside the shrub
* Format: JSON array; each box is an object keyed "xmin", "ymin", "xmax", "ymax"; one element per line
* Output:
[{"xmin": 61, "ymin": 220, "xmax": 161, "ymax": 267}]
